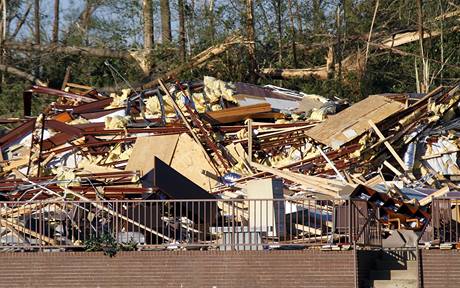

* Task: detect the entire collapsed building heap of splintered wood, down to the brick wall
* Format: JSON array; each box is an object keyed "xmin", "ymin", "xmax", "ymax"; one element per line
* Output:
[{"xmin": 0, "ymin": 77, "xmax": 460, "ymax": 250}]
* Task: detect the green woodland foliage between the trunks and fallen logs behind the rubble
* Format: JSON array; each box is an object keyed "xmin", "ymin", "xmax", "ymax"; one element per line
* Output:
[{"xmin": 0, "ymin": 0, "xmax": 460, "ymax": 118}]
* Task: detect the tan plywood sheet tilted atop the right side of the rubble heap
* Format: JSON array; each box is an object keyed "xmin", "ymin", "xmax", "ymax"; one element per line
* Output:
[{"xmin": 306, "ymin": 95, "xmax": 404, "ymax": 149}]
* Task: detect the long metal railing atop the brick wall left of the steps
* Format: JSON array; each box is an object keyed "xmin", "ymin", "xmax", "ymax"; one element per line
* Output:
[{"xmin": 0, "ymin": 199, "xmax": 381, "ymax": 250}]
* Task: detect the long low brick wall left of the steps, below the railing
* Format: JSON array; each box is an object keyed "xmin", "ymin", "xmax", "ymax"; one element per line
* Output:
[{"xmin": 0, "ymin": 250, "xmax": 354, "ymax": 288}]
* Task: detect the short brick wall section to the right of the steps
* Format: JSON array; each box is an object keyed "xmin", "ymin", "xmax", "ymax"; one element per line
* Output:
[{"xmin": 421, "ymin": 250, "xmax": 460, "ymax": 288}]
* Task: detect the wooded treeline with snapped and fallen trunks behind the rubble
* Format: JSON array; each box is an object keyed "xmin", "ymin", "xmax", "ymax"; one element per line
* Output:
[{"xmin": 0, "ymin": 0, "xmax": 460, "ymax": 116}]
